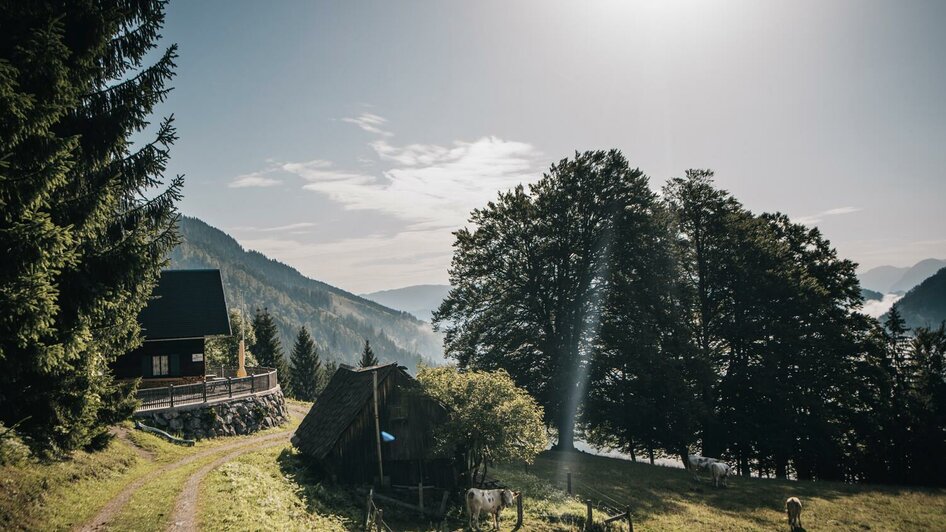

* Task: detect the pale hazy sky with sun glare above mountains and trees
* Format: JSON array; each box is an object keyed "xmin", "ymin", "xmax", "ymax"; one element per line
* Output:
[{"xmin": 154, "ymin": 0, "xmax": 946, "ymax": 293}]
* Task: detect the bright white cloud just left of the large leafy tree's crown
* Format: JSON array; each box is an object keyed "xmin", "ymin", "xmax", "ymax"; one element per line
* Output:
[{"xmin": 282, "ymin": 137, "xmax": 541, "ymax": 229}]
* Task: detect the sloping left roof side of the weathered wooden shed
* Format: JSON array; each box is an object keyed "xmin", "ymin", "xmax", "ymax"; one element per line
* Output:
[{"xmin": 292, "ymin": 362, "xmax": 402, "ymax": 460}]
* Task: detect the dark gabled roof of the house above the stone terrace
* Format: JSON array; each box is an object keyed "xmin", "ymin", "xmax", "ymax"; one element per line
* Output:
[{"xmin": 138, "ymin": 270, "xmax": 231, "ymax": 341}]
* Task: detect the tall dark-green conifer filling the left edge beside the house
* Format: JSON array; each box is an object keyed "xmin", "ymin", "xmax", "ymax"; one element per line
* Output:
[{"xmin": 0, "ymin": 0, "xmax": 183, "ymax": 454}]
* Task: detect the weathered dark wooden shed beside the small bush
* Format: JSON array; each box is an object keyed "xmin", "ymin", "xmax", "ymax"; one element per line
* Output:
[{"xmin": 292, "ymin": 363, "xmax": 457, "ymax": 489}]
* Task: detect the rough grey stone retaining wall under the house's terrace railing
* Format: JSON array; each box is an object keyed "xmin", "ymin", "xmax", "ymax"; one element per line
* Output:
[{"xmin": 134, "ymin": 387, "xmax": 289, "ymax": 440}]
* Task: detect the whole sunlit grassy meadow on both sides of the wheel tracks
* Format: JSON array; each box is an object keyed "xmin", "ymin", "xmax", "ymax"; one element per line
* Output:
[{"xmin": 0, "ymin": 421, "xmax": 946, "ymax": 532}]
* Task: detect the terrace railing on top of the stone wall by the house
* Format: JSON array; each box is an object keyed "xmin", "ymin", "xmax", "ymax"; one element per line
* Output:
[{"xmin": 137, "ymin": 368, "xmax": 278, "ymax": 412}]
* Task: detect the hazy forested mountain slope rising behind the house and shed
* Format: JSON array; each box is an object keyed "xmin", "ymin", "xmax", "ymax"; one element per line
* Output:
[{"xmin": 171, "ymin": 217, "xmax": 443, "ymax": 370}]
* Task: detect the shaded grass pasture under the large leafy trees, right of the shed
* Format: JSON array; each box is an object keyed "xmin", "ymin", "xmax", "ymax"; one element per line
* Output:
[{"xmin": 497, "ymin": 452, "xmax": 946, "ymax": 531}]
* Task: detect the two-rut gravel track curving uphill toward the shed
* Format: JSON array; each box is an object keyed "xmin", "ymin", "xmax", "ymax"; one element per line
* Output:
[{"xmin": 76, "ymin": 404, "xmax": 308, "ymax": 532}]
